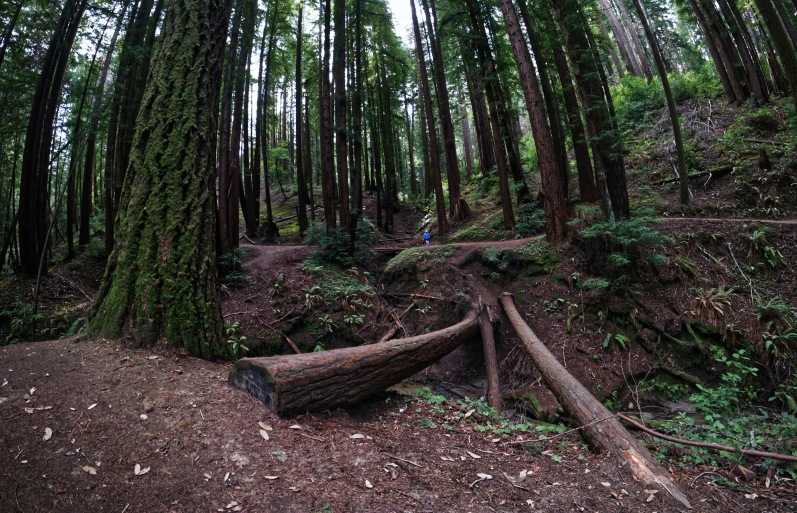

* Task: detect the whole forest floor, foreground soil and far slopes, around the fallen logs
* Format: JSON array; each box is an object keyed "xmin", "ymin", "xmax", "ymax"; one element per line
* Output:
[{"xmin": 0, "ymin": 98, "xmax": 797, "ymax": 513}]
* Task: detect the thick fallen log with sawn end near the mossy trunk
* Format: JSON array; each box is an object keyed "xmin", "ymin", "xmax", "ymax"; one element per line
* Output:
[{"xmin": 229, "ymin": 307, "xmax": 479, "ymax": 415}]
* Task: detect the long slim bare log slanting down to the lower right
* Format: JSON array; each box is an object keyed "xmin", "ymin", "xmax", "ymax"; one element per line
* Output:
[{"xmin": 501, "ymin": 293, "xmax": 692, "ymax": 509}]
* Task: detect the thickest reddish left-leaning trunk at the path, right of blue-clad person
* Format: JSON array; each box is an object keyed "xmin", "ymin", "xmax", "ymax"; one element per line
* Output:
[{"xmin": 500, "ymin": 0, "xmax": 567, "ymax": 243}]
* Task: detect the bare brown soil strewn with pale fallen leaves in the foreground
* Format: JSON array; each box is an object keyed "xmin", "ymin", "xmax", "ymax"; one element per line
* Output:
[{"xmin": 0, "ymin": 339, "xmax": 793, "ymax": 512}]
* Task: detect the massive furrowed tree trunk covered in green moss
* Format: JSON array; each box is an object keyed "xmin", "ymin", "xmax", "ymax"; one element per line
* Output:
[{"xmin": 89, "ymin": 0, "xmax": 230, "ymax": 357}]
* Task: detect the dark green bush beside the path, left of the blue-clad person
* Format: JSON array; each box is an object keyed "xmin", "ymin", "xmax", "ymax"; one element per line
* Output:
[{"xmin": 305, "ymin": 218, "xmax": 376, "ymax": 267}]
